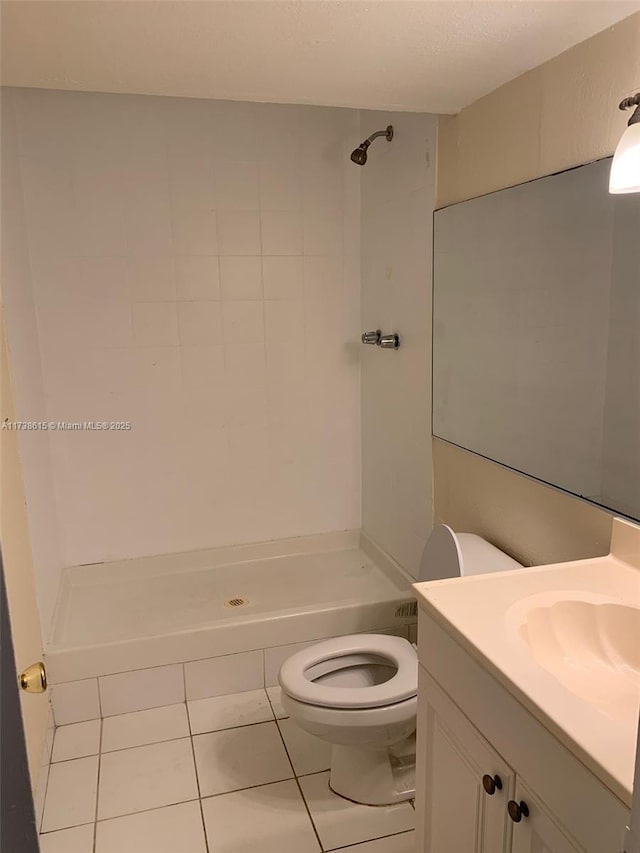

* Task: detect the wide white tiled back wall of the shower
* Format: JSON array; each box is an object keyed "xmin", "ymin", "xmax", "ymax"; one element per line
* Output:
[{"xmin": 7, "ymin": 89, "xmax": 361, "ymax": 568}]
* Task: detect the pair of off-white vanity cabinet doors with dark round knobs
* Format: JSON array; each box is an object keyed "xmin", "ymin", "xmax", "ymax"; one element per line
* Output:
[{"xmin": 416, "ymin": 667, "xmax": 582, "ymax": 853}]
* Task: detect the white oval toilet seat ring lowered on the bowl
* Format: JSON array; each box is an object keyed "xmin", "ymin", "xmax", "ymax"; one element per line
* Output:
[{"xmin": 279, "ymin": 634, "xmax": 418, "ymax": 709}]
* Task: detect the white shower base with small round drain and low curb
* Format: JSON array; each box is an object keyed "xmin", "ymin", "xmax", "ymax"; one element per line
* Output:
[{"xmin": 45, "ymin": 531, "xmax": 415, "ymax": 684}]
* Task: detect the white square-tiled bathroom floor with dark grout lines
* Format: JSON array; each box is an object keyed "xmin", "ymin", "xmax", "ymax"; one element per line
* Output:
[{"xmin": 40, "ymin": 687, "xmax": 415, "ymax": 853}]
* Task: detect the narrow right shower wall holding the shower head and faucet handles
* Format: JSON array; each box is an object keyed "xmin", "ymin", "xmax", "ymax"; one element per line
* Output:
[{"xmin": 362, "ymin": 112, "xmax": 436, "ymax": 576}]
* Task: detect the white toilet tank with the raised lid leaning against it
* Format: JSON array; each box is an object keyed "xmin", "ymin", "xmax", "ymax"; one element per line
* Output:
[{"xmin": 418, "ymin": 524, "xmax": 522, "ymax": 582}]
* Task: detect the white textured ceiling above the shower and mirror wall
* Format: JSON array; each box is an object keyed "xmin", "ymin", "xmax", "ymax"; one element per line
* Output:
[{"xmin": 1, "ymin": 0, "xmax": 640, "ymax": 113}]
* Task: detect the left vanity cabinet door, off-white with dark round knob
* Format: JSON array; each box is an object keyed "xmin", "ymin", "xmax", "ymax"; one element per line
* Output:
[{"xmin": 416, "ymin": 670, "xmax": 515, "ymax": 853}]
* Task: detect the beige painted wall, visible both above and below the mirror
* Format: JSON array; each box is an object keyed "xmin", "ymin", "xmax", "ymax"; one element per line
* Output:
[{"xmin": 433, "ymin": 13, "xmax": 640, "ymax": 564}]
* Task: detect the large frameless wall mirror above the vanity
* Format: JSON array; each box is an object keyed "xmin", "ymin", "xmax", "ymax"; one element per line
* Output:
[{"xmin": 433, "ymin": 158, "xmax": 640, "ymax": 519}]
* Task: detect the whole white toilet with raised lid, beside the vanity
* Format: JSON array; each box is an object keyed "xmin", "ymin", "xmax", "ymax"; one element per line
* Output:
[{"xmin": 279, "ymin": 524, "xmax": 522, "ymax": 806}]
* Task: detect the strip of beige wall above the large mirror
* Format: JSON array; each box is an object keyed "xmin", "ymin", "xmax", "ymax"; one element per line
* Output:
[{"xmin": 436, "ymin": 12, "xmax": 640, "ymax": 207}]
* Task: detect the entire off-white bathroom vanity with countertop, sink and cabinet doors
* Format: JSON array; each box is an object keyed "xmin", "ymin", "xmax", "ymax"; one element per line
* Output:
[{"xmin": 415, "ymin": 519, "xmax": 640, "ymax": 853}]
